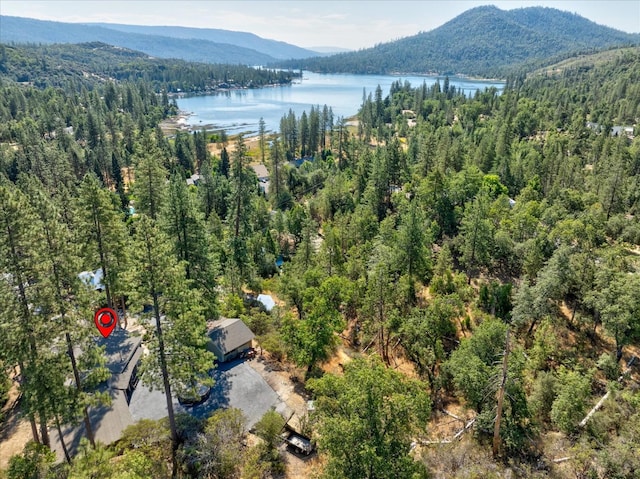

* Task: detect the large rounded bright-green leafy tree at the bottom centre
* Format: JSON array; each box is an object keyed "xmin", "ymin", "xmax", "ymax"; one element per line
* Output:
[{"xmin": 309, "ymin": 358, "xmax": 431, "ymax": 479}]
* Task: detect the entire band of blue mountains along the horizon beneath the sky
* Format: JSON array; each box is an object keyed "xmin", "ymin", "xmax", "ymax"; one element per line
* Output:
[{"xmin": 0, "ymin": 6, "xmax": 640, "ymax": 78}]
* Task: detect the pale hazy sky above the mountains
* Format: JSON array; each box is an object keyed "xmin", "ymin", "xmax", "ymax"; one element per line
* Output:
[{"xmin": 0, "ymin": 0, "xmax": 640, "ymax": 49}]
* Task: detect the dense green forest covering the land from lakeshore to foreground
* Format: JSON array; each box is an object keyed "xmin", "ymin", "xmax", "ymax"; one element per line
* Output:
[{"xmin": 0, "ymin": 42, "xmax": 640, "ymax": 479}]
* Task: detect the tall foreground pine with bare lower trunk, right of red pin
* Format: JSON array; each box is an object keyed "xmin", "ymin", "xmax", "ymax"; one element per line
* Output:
[{"xmin": 132, "ymin": 215, "xmax": 214, "ymax": 471}]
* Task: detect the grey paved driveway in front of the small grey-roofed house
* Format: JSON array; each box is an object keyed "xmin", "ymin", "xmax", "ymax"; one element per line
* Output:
[{"xmin": 129, "ymin": 359, "xmax": 288, "ymax": 428}]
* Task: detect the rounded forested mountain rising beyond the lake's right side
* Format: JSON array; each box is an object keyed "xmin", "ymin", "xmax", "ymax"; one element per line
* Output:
[{"xmin": 285, "ymin": 6, "xmax": 640, "ymax": 77}]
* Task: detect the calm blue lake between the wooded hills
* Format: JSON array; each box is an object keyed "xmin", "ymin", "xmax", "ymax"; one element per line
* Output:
[{"xmin": 176, "ymin": 71, "xmax": 504, "ymax": 134}]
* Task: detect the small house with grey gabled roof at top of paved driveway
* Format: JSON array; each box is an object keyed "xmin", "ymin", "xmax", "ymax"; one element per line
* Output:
[{"xmin": 207, "ymin": 318, "xmax": 255, "ymax": 363}]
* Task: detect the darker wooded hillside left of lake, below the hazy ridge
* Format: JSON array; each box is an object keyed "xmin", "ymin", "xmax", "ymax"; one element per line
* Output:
[{"xmin": 0, "ymin": 42, "xmax": 299, "ymax": 93}]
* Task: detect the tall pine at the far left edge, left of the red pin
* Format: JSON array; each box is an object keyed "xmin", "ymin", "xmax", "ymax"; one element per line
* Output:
[{"xmin": 0, "ymin": 183, "xmax": 65, "ymax": 446}]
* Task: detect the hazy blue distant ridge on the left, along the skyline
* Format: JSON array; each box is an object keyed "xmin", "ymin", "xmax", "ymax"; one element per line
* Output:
[{"xmin": 0, "ymin": 15, "xmax": 317, "ymax": 65}]
